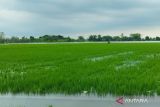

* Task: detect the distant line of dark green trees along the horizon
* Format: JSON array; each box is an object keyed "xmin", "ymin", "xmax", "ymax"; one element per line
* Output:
[{"xmin": 0, "ymin": 32, "xmax": 160, "ymax": 43}]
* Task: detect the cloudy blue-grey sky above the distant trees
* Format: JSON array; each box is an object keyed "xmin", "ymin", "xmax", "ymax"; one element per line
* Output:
[{"xmin": 0, "ymin": 0, "xmax": 160, "ymax": 36}]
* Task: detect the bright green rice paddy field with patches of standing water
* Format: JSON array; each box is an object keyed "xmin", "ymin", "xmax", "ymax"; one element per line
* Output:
[{"xmin": 0, "ymin": 43, "xmax": 160, "ymax": 95}]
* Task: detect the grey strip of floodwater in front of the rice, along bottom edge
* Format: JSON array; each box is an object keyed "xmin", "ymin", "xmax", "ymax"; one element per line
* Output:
[{"xmin": 0, "ymin": 94, "xmax": 160, "ymax": 107}]
